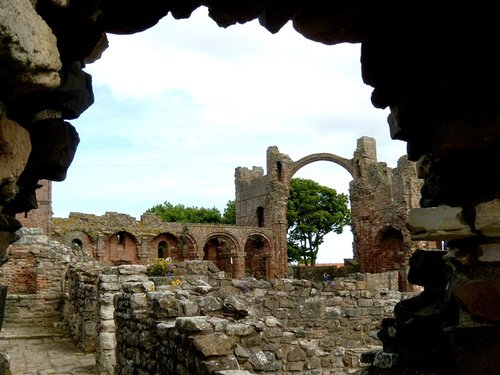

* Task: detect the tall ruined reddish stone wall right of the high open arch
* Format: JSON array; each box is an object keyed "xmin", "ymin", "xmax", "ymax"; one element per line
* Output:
[{"xmin": 350, "ymin": 137, "xmax": 433, "ymax": 290}]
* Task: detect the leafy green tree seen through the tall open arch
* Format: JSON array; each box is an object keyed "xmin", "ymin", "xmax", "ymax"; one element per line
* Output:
[{"xmin": 287, "ymin": 178, "xmax": 351, "ymax": 266}]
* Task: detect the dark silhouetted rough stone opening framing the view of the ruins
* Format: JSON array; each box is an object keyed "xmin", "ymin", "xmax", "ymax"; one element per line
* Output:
[{"xmin": 0, "ymin": 0, "xmax": 500, "ymax": 374}]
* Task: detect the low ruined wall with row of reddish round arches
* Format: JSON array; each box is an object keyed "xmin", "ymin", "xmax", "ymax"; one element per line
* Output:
[{"xmin": 52, "ymin": 212, "xmax": 277, "ymax": 277}]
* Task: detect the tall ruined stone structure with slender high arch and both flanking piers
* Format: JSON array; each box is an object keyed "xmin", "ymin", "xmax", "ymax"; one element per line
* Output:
[{"xmin": 236, "ymin": 137, "xmax": 440, "ymax": 290}]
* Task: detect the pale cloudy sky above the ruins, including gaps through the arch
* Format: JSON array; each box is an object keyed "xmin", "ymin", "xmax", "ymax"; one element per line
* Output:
[{"xmin": 53, "ymin": 8, "xmax": 406, "ymax": 262}]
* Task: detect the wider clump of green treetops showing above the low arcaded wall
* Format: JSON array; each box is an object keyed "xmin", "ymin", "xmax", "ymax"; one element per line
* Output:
[{"xmin": 146, "ymin": 201, "xmax": 222, "ymax": 224}]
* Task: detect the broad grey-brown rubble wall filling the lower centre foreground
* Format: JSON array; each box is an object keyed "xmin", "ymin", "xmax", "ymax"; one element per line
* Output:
[{"xmin": 116, "ymin": 277, "xmax": 401, "ymax": 374}]
